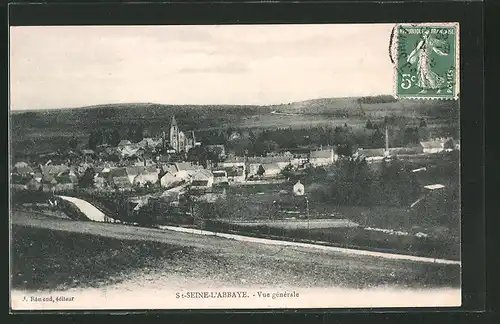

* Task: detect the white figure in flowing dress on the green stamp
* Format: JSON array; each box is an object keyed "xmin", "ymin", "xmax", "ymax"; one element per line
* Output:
[{"xmin": 407, "ymin": 29, "xmax": 448, "ymax": 93}]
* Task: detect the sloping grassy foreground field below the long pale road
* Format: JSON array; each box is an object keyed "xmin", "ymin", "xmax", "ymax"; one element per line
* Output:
[{"xmin": 11, "ymin": 220, "xmax": 460, "ymax": 291}]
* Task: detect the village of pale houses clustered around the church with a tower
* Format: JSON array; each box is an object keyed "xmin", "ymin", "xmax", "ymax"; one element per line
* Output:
[{"xmin": 11, "ymin": 116, "xmax": 460, "ymax": 218}]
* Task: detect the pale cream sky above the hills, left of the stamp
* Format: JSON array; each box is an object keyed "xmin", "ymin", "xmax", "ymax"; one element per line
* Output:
[{"xmin": 10, "ymin": 24, "xmax": 393, "ymax": 110}]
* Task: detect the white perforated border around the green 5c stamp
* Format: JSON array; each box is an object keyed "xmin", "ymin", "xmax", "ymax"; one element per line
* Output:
[{"xmin": 389, "ymin": 22, "xmax": 461, "ymax": 100}]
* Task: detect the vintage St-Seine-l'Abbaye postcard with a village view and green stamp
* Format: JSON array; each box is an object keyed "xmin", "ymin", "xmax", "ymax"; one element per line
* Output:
[{"xmin": 9, "ymin": 22, "xmax": 461, "ymax": 311}]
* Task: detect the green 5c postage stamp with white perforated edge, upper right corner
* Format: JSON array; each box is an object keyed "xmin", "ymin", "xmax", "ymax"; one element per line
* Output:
[{"xmin": 391, "ymin": 23, "xmax": 460, "ymax": 100}]
